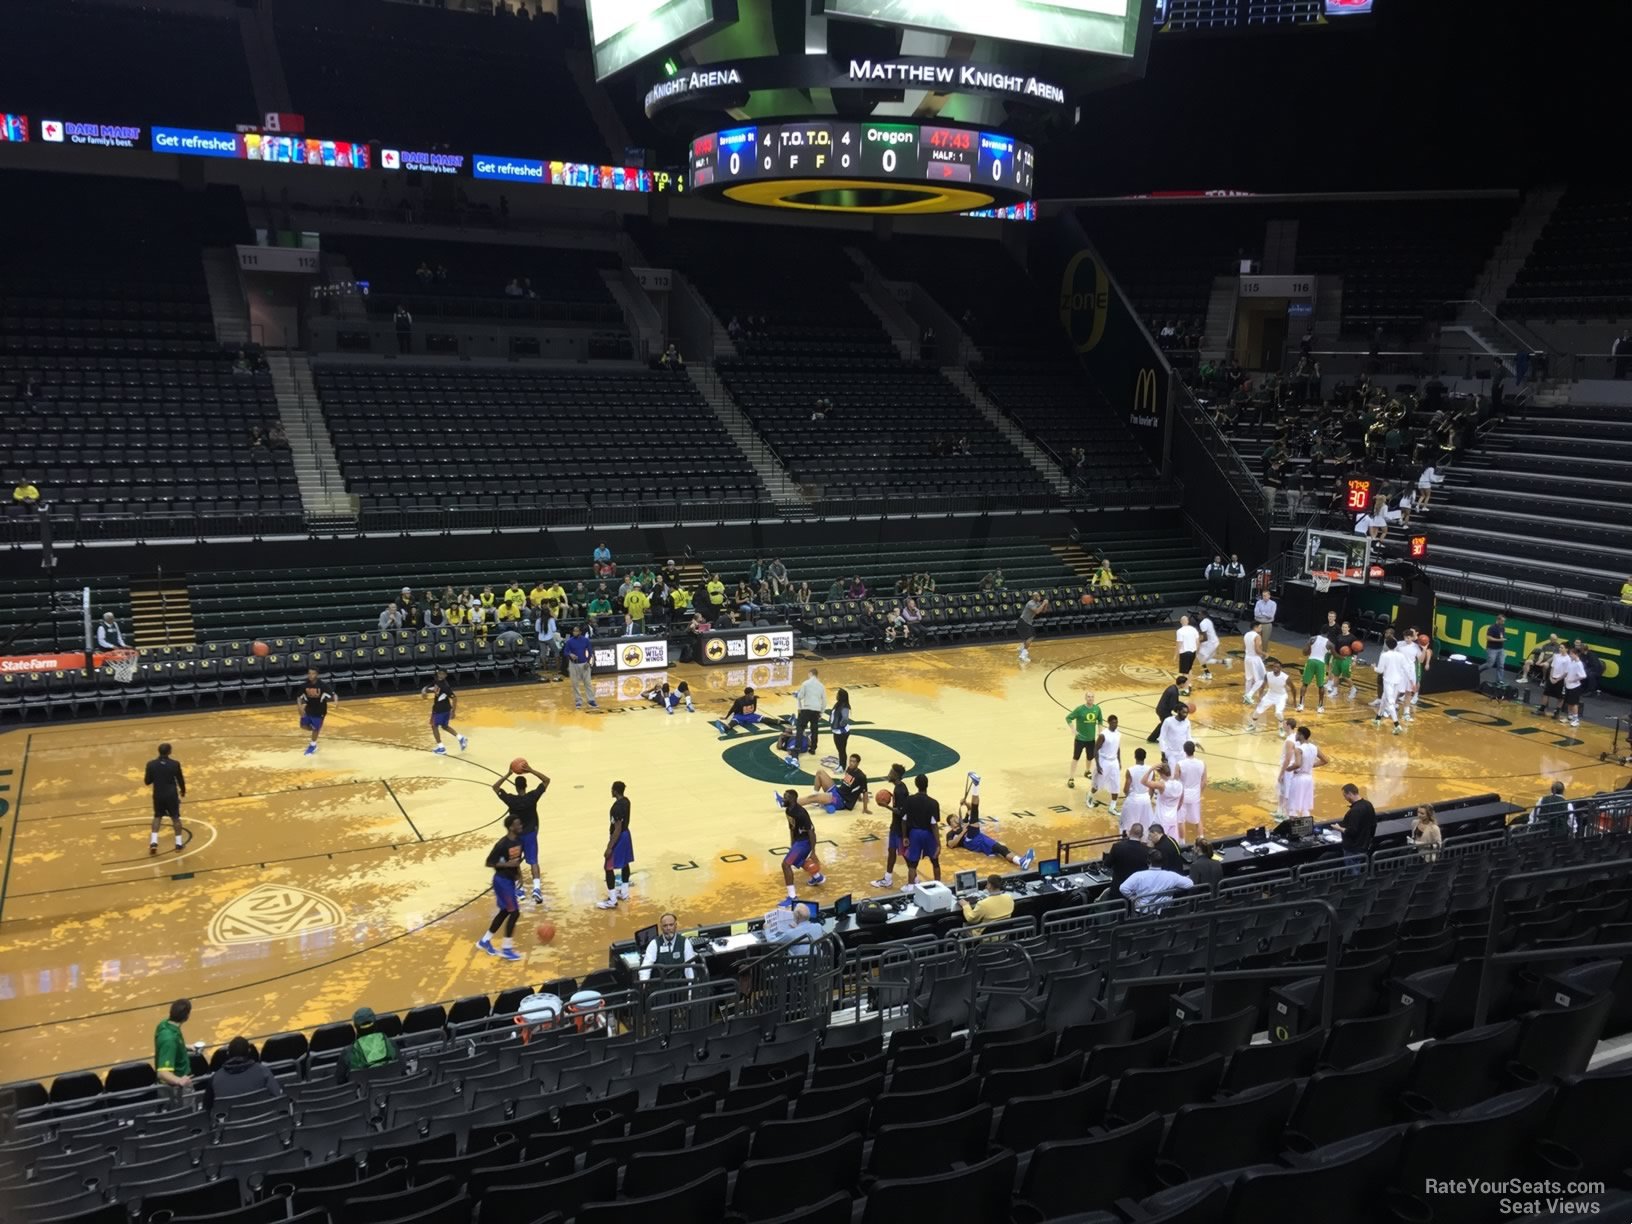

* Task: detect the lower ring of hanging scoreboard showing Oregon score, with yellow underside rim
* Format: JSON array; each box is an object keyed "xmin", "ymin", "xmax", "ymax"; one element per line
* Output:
[{"xmin": 690, "ymin": 118, "xmax": 1033, "ymax": 212}]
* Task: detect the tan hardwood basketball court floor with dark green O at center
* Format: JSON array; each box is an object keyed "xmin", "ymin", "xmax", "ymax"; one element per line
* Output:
[{"xmin": 0, "ymin": 630, "xmax": 1624, "ymax": 1082}]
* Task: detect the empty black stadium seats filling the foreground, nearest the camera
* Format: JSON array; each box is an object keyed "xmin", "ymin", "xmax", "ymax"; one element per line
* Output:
[{"xmin": 0, "ymin": 834, "xmax": 1632, "ymax": 1224}]
